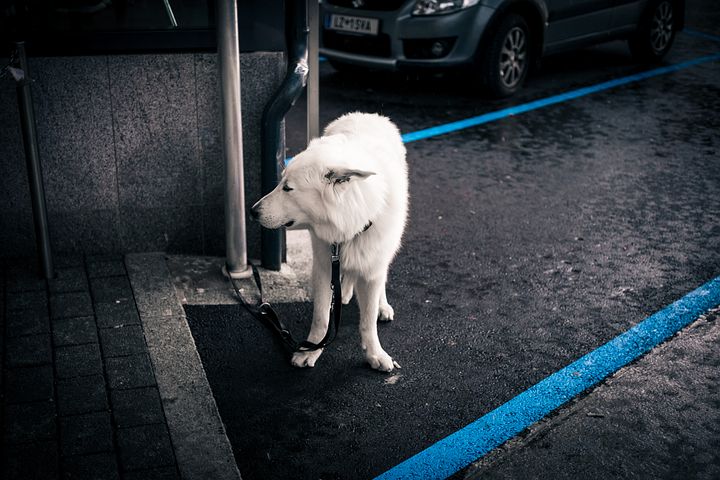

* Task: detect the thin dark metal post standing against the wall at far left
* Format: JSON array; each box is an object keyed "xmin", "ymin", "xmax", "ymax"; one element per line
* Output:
[{"xmin": 15, "ymin": 42, "xmax": 55, "ymax": 279}]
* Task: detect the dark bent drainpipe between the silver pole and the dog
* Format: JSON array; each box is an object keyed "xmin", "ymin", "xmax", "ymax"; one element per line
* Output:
[{"xmin": 260, "ymin": 0, "xmax": 310, "ymax": 270}]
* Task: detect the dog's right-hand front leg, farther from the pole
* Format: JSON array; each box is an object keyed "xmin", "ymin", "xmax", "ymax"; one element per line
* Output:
[{"xmin": 355, "ymin": 277, "xmax": 399, "ymax": 372}]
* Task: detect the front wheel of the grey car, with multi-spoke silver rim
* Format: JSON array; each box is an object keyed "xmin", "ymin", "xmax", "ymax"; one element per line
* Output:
[{"xmin": 480, "ymin": 14, "xmax": 532, "ymax": 98}]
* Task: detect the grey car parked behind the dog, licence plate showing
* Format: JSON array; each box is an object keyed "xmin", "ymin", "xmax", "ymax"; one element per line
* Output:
[{"xmin": 320, "ymin": 0, "xmax": 685, "ymax": 97}]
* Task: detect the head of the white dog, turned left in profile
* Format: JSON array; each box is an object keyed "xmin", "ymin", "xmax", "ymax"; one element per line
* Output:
[{"xmin": 251, "ymin": 141, "xmax": 376, "ymax": 242}]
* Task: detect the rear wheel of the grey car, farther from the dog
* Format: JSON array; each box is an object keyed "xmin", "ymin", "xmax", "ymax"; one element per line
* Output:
[{"xmin": 628, "ymin": 0, "xmax": 677, "ymax": 63}]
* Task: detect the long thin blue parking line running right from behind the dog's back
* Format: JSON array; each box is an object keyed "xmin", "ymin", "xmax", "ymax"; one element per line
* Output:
[{"xmin": 402, "ymin": 54, "xmax": 720, "ymax": 143}]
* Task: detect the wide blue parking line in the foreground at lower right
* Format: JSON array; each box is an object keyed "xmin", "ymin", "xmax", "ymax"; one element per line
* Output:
[{"xmin": 376, "ymin": 277, "xmax": 720, "ymax": 480}]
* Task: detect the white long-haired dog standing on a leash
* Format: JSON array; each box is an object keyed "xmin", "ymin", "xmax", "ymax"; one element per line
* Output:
[{"xmin": 252, "ymin": 113, "xmax": 408, "ymax": 372}]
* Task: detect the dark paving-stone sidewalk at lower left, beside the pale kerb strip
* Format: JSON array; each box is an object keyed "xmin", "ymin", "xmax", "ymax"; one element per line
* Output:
[{"xmin": 0, "ymin": 256, "xmax": 180, "ymax": 480}]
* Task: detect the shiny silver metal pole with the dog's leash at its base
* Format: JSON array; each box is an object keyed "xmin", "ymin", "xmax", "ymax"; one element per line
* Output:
[{"xmin": 217, "ymin": 0, "xmax": 251, "ymax": 278}]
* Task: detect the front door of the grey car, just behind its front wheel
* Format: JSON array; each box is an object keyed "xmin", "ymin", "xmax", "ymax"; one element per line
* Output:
[{"xmin": 545, "ymin": 0, "xmax": 614, "ymax": 53}]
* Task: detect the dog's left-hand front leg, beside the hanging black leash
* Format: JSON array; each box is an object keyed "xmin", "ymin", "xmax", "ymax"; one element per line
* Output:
[{"xmin": 291, "ymin": 239, "xmax": 332, "ymax": 368}]
